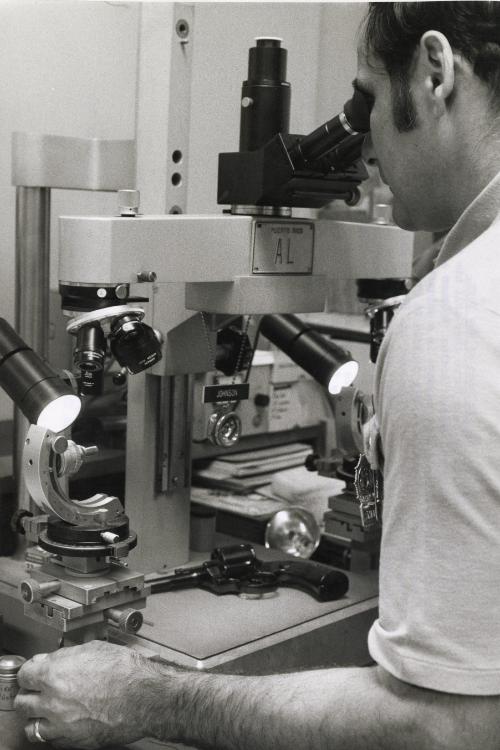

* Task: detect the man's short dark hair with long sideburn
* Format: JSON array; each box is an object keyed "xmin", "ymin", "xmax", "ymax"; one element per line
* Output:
[{"xmin": 364, "ymin": 0, "xmax": 500, "ymax": 130}]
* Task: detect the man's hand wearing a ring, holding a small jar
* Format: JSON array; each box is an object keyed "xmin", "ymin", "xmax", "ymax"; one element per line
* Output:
[{"xmin": 16, "ymin": 641, "xmax": 166, "ymax": 750}]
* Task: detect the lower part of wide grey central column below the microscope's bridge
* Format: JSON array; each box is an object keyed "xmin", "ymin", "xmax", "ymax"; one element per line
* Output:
[{"xmin": 125, "ymin": 372, "xmax": 192, "ymax": 573}]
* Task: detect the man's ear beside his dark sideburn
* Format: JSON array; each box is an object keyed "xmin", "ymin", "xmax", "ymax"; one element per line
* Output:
[{"xmin": 417, "ymin": 31, "xmax": 455, "ymax": 116}]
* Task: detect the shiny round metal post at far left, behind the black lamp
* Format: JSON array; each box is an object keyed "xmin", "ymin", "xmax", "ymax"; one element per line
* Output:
[{"xmin": 13, "ymin": 187, "xmax": 50, "ymax": 508}]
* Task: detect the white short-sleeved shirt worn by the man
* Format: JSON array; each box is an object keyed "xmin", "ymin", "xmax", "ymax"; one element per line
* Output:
[{"xmin": 368, "ymin": 175, "xmax": 500, "ymax": 695}]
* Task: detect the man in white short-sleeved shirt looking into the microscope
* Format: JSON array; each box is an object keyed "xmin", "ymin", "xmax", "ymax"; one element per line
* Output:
[{"xmin": 12, "ymin": 2, "xmax": 500, "ymax": 750}]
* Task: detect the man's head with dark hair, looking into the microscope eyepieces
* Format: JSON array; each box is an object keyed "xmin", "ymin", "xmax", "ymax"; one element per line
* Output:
[{"xmin": 356, "ymin": 2, "xmax": 500, "ymax": 231}]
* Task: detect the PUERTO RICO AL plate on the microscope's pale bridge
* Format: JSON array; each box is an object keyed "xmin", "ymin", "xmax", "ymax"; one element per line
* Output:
[{"xmin": 252, "ymin": 219, "xmax": 314, "ymax": 276}]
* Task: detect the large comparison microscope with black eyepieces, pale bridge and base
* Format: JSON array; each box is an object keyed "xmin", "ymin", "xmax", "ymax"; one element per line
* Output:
[{"xmin": 0, "ymin": 37, "xmax": 413, "ymax": 671}]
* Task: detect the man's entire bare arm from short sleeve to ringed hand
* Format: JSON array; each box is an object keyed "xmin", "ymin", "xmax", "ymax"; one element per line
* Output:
[{"xmin": 12, "ymin": 641, "xmax": 500, "ymax": 750}]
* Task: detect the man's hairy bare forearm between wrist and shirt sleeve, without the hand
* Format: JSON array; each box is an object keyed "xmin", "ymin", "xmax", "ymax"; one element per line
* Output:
[{"xmin": 143, "ymin": 665, "xmax": 499, "ymax": 750}]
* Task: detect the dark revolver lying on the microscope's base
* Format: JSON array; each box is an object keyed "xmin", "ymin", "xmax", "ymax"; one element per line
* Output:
[{"xmin": 151, "ymin": 544, "xmax": 349, "ymax": 602}]
